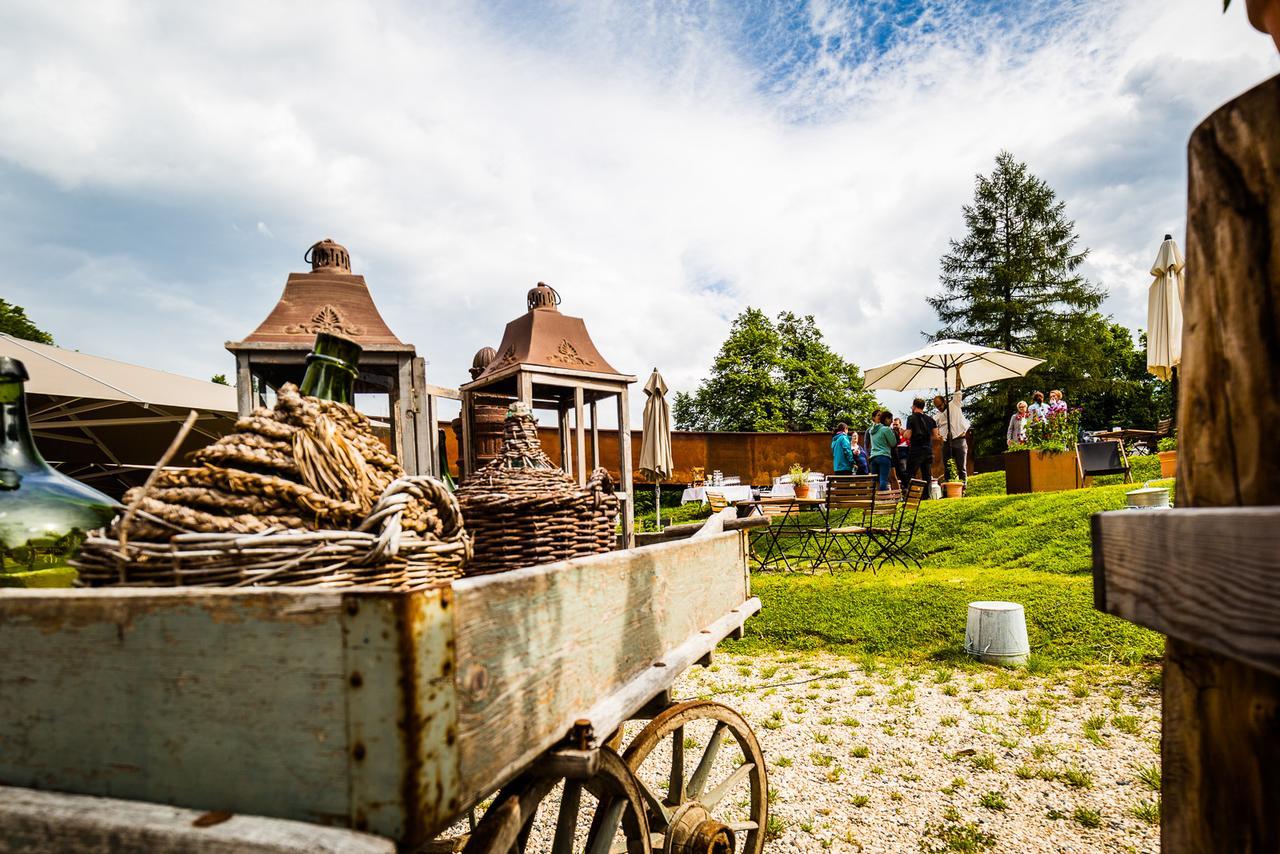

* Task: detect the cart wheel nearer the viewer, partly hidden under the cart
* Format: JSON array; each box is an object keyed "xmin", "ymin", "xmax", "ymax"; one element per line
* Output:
[{"xmin": 462, "ymin": 748, "xmax": 653, "ymax": 854}]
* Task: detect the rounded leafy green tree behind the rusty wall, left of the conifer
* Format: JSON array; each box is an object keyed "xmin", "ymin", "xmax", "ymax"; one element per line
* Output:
[{"xmin": 673, "ymin": 307, "xmax": 876, "ymax": 433}]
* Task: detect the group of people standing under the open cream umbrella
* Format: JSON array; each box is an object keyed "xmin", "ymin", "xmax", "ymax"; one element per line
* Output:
[{"xmin": 831, "ymin": 375, "xmax": 969, "ymax": 492}]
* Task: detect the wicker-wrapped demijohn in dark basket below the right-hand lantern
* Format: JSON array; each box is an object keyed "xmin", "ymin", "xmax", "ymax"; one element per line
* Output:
[{"xmin": 458, "ymin": 403, "xmax": 618, "ymax": 575}]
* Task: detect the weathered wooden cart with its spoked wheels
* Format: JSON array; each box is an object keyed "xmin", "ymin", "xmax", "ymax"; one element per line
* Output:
[{"xmin": 0, "ymin": 517, "xmax": 768, "ymax": 854}]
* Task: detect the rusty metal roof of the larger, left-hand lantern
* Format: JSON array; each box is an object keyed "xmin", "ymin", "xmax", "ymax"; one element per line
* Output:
[{"xmin": 228, "ymin": 238, "xmax": 413, "ymax": 351}]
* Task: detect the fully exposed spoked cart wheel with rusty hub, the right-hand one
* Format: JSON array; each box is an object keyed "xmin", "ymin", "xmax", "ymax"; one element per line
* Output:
[{"xmin": 604, "ymin": 700, "xmax": 769, "ymax": 854}]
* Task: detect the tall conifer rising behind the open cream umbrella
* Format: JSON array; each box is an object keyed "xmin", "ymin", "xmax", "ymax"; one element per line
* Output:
[{"xmin": 929, "ymin": 151, "xmax": 1108, "ymax": 452}]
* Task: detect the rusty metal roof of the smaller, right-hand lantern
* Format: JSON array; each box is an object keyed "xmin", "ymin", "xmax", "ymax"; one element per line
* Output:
[{"xmin": 467, "ymin": 282, "xmax": 635, "ymax": 385}]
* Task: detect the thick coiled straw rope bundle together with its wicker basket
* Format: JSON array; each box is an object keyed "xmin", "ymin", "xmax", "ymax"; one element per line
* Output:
[{"xmin": 76, "ymin": 385, "xmax": 471, "ymax": 589}]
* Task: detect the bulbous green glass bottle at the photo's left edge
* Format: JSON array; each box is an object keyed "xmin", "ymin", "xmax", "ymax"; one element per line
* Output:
[{"xmin": 0, "ymin": 356, "xmax": 119, "ymax": 586}]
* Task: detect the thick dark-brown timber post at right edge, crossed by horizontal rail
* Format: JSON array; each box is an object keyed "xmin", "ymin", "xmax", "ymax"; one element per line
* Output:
[{"xmin": 1161, "ymin": 77, "xmax": 1280, "ymax": 854}]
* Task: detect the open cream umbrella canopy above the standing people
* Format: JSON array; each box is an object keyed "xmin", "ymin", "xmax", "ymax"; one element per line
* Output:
[{"xmin": 865, "ymin": 338, "xmax": 1044, "ymax": 392}]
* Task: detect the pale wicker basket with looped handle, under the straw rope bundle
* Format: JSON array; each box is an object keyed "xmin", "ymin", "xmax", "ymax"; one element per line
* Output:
[{"xmin": 73, "ymin": 476, "xmax": 471, "ymax": 590}]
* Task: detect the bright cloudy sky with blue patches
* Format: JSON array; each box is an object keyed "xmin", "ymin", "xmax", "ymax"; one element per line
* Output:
[{"xmin": 0, "ymin": 0, "xmax": 1280, "ymax": 422}]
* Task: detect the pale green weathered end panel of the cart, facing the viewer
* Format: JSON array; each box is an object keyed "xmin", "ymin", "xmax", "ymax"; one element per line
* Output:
[{"xmin": 0, "ymin": 589, "xmax": 349, "ymax": 825}]
